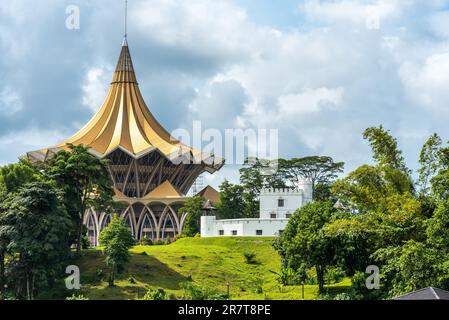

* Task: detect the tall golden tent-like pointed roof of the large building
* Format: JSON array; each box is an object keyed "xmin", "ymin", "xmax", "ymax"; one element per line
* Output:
[{"xmin": 27, "ymin": 39, "xmax": 224, "ymax": 173}]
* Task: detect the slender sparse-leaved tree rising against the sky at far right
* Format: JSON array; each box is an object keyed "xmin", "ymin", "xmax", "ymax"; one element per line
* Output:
[{"xmin": 418, "ymin": 133, "xmax": 442, "ymax": 195}]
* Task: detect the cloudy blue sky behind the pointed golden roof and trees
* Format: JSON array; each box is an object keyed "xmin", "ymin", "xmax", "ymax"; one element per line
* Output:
[{"xmin": 0, "ymin": 0, "xmax": 449, "ymax": 185}]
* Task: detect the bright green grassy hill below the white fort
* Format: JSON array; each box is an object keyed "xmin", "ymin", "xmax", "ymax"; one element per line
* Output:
[{"xmin": 73, "ymin": 238, "xmax": 349, "ymax": 300}]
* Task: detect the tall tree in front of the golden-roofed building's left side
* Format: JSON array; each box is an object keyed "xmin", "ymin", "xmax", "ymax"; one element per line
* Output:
[{"xmin": 46, "ymin": 145, "xmax": 114, "ymax": 254}]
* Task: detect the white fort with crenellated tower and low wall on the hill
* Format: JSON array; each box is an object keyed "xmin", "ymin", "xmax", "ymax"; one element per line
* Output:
[{"xmin": 201, "ymin": 183, "xmax": 312, "ymax": 237}]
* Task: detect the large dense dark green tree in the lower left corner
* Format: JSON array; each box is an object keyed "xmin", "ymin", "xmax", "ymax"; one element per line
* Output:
[{"xmin": 2, "ymin": 182, "xmax": 71, "ymax": 299}]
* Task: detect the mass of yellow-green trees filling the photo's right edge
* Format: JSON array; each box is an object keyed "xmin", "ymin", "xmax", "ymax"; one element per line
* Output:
[{"xmin": 324, "ymin": 127, "xmax": 449, "ymax": 299}]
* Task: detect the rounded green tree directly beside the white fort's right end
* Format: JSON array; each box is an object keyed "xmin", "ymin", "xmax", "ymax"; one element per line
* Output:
[{"xmin": 275, "ymin": 202, "xmax": 335, "ymax": 292}]
